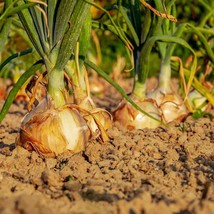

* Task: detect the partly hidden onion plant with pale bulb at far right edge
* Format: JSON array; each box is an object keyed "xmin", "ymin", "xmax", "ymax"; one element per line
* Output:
[{"xmin": 185, "ymin": 1, "xmax": 214, "ymax": 112}]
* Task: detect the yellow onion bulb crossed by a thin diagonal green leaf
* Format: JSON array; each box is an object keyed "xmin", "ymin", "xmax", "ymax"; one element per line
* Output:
[{"xmin": 114, "ymin": 100, "xmax": 161, "ymax": 130}]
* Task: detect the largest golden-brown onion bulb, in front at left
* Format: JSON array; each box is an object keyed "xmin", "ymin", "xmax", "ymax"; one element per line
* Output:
[{"xmin": 17, "ymin": 105, "xmax": 90, "ymax": 157}]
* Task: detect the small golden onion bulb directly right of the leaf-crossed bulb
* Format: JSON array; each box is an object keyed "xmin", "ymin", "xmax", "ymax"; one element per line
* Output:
[{"xmin": 147, "ymin": 88, "xmax": 188, "ymax": 123}]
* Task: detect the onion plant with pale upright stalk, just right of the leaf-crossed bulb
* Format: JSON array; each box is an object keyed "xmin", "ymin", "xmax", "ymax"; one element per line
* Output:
[{"xmin": 148, "ymin": 1, "xmax": 187, "ymax": 123}]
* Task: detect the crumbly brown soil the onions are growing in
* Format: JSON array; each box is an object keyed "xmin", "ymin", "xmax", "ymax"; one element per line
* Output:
[{"xmin": 0, "ymin": 77, "xmax": 214, "ymax": 214}]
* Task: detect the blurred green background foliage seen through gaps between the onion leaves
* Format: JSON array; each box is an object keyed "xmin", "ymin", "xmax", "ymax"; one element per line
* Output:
[{"xmin": 0, "ymin": 0, "xmax": 214, "ymax": 81}]
